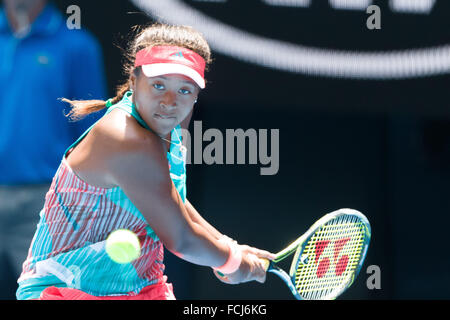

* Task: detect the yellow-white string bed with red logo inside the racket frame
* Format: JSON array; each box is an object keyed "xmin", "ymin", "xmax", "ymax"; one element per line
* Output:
[{"xmin": 295, "ymin": 215, "xmax": 365, "ymax": 299}]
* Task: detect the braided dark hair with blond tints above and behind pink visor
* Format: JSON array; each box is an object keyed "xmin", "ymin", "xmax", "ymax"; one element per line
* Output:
[{"xmin": 61, "ymin": 23, "xmax": 212, "ymax": 121}]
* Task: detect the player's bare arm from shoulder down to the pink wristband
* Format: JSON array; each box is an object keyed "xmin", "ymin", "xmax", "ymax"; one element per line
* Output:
[{"xmin": 106, "ymin": 130, "xmax": 229, "ymax": 267}]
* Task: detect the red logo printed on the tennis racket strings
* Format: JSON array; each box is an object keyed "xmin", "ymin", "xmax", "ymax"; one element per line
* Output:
[{"xmin": 315, "ymin": 238, "xmax": 350, "ymax": 278}]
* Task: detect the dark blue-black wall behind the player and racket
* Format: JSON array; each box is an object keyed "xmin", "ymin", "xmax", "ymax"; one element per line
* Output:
[{"xmin": 17, "ymin": 0, "xmax": 450, "ymax": 299}]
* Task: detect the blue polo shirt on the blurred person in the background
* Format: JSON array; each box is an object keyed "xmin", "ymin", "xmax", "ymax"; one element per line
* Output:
[{"xmin": 0, "ymin": 4, "xmax": 106, "ymax": 185}]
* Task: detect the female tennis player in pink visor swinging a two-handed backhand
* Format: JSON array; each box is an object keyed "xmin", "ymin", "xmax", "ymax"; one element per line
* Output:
[{"xmin": 17, "ymin": 24, "xmax": 274, "ymax": 300}]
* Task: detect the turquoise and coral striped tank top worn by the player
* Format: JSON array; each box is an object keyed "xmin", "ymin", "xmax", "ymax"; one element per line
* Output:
[{"xmin": 16, "ymin": 92, "xmax": 186, "ymax": 300}]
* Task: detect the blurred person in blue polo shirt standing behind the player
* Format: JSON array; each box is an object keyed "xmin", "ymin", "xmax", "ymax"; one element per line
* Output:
[{"xmin": 0, "ymin": 0, "xmax": 106, "ymax": 299}]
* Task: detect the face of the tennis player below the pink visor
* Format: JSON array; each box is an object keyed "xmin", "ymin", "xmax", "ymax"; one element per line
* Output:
[{"xmin": 131, "ymin": 72, "xmax": 200, "ymax": 135}]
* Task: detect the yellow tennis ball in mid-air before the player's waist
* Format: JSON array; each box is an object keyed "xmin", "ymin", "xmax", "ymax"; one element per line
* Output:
[{"xmin": 105, "ymin": 229, "xmax": 141, "ymax": 263}]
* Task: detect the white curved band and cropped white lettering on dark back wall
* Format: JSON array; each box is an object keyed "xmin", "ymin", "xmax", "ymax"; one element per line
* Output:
[{"xmin": 131, "ymin": 0, "xmax": 450, "ymax": 79}]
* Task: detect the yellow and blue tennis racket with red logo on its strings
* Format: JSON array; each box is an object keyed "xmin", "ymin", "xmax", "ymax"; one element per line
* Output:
[{"xmin": 264, "ymin": 209, "xmax": 371, "ymax": 300}]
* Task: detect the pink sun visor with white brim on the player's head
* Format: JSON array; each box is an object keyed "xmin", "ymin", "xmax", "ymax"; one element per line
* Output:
[{"xmin": 134, "ymin": 46, "xmax": 205, "ymax": 89}]
